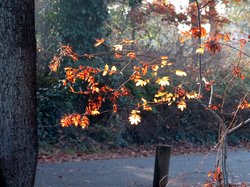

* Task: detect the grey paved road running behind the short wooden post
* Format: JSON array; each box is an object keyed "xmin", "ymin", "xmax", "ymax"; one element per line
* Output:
[{"xmin": 35, "ymin": 151, "xmax": 250, "ymax": 187}]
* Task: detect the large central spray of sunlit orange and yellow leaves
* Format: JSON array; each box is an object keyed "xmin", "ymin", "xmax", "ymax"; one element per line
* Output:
[{"xmin": 50, "ymin": 39, "xmax": 202, "ymax": 128}]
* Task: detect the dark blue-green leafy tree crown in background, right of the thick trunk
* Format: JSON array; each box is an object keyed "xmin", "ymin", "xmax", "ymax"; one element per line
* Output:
[{"xmin": 45, "ymin": 0, "xmax": 108, "ymax": 51}]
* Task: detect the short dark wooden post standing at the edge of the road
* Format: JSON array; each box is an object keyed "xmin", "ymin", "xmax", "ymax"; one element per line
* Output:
[{"xmin": 153, "ymin": 145, "xmax": 171, "ymax": 187}]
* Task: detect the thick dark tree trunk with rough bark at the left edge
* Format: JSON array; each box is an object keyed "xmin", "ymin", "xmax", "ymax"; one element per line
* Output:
[{"xmin": 0, "ymin": 0, "xmax": 37, "ymax": 187}]
